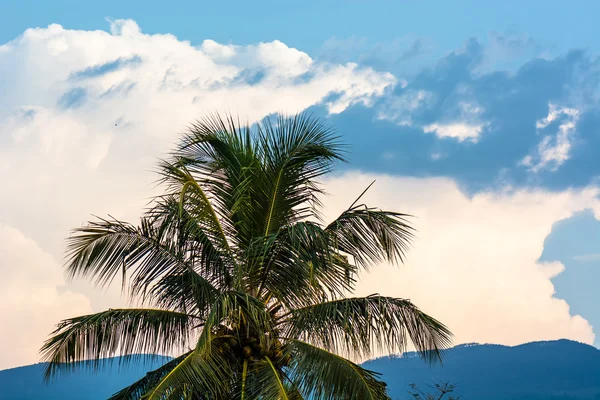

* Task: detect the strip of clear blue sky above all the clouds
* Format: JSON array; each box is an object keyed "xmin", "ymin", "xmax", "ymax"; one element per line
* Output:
[{"xmin": 0, "ymin": 0, "xmax": 600, "ymax": 55}]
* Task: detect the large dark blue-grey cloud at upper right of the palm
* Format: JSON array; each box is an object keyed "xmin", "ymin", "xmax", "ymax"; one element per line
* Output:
[{"xmin": 312, "ymin": 39, "xmax": 600, "ymax": 192}]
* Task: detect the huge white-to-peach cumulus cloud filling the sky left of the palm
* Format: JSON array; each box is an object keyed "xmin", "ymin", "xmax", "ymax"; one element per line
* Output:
[{"xmin": 0, "ymin": 20, "xmax": 396, "ymax": 368}]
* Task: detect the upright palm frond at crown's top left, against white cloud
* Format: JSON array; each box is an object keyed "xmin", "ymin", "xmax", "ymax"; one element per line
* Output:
[{"xmin": 163, "ymin": 115, "xmax": 261, "ymax": 248}]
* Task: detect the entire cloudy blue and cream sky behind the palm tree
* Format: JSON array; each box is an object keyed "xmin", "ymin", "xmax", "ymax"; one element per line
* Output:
[{"xmin": 0, "ymin": 0, "xmax": 600, "ymax": 369}]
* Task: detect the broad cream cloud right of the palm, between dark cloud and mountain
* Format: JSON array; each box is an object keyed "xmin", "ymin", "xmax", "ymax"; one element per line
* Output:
[{"xmin": 325, "ymin": 173, "xmax": 600, "ymax": 354}]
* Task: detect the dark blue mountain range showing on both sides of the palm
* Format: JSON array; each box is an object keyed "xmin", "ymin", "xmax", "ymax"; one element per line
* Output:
[{"xmin": 0, "ymin": 340, "xmax": 600, "ymax": 400}]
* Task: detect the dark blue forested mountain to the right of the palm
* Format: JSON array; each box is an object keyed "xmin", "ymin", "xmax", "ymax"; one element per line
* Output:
[{"xmin": 364, "ymin": 340, "xmax": 600, "ymax": 400}]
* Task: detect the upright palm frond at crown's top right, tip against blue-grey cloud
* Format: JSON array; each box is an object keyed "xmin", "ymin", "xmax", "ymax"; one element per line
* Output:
[{"xmin": 255, "ymin": 114, "xmax": 344, "ymax": 236}]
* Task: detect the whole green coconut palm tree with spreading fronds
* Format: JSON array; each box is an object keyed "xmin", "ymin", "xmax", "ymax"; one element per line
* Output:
[{"xmin": 42, "ymin": 114, "xmax": 451, "ymax": 400}]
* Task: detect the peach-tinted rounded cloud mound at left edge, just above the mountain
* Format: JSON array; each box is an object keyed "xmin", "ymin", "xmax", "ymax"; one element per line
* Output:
[{"xmin": 0, "ymin": 224, "xmax": 91, "ymax": 369}]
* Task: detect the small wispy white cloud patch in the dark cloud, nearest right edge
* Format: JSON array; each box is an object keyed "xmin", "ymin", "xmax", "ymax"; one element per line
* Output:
[{"xmin": 521, "ymin": 104, "xmax": 579, "ymax": 172}]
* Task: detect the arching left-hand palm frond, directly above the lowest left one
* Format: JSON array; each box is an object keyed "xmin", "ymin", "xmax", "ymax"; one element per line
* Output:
[{"xmin": 67, "ymin": 212, "xmax": 225, "ymax": 312}]
